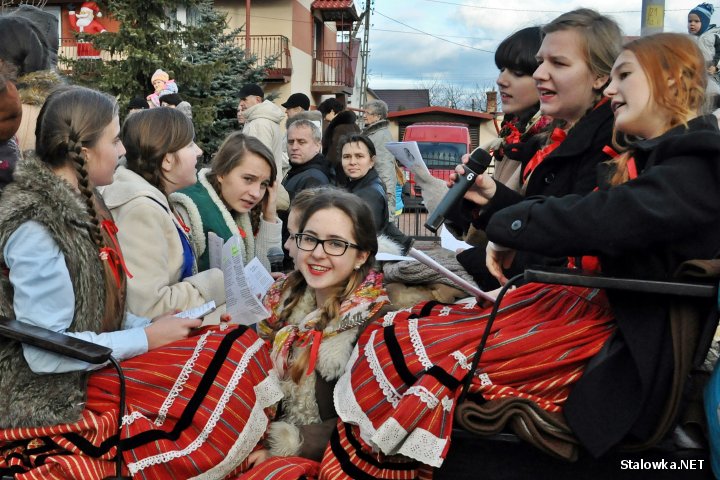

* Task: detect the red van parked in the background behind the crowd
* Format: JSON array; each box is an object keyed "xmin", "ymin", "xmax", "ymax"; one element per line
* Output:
[{"xmin": 403, "ymin": 122, "xmax": 470, "ymax": 197}]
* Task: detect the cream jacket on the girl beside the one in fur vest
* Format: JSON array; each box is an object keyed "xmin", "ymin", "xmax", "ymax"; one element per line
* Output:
[{"xmin": 101, "ymin": 166, "xmax": 225, "ymax": 318}]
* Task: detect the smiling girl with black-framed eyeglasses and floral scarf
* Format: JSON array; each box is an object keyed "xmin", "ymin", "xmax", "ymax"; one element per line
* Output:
[{"xmin": 245, "ymin": 189, "xmax": 388, "ymax": 470}]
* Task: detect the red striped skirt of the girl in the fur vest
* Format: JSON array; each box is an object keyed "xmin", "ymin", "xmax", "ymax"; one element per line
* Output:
[{"xmin": 0, "ymin": 327, "xmax": 281, "ymax": 480}]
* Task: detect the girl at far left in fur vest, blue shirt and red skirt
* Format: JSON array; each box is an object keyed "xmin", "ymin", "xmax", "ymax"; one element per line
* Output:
[{"xmin": 0, "ymin": 87, "xmax": 281, "ymax": 479}]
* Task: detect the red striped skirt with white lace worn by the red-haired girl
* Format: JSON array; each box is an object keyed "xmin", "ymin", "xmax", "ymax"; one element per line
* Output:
[{"xmin": 328, "ymin": 284, "xmax": 614, "ymax": 467}]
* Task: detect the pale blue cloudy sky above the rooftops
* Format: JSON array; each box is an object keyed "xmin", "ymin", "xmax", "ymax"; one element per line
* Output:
[{"xmin": 362, "ymin": 0, "xmax": 700, "ymax": 89}]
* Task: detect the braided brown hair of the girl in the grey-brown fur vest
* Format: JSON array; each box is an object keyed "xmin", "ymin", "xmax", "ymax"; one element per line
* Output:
[{"xmin": 35, "ymin": 86, "xmax": 118, "ymax": 248}]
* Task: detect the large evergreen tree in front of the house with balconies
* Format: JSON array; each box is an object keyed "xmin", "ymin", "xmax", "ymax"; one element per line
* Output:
[{"xmin": 69, "ymin": 0, "xmax": 272, "ymax": 158}]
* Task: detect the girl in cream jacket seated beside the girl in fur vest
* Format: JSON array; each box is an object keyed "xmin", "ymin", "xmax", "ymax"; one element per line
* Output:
[{"xmin": 102, "ymin": 108, "xmax": 225, "ymax": 318}]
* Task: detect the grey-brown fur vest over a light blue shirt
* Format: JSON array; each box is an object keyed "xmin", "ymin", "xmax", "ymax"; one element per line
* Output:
[{"xmin": 0, "ymin": 156, "xmax": 124, "ymax": 428}]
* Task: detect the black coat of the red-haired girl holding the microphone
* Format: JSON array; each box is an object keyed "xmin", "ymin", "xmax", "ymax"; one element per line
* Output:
[{"xmin": 486, "ymin": 116, "xmax": 720, "ymax": 455}]
